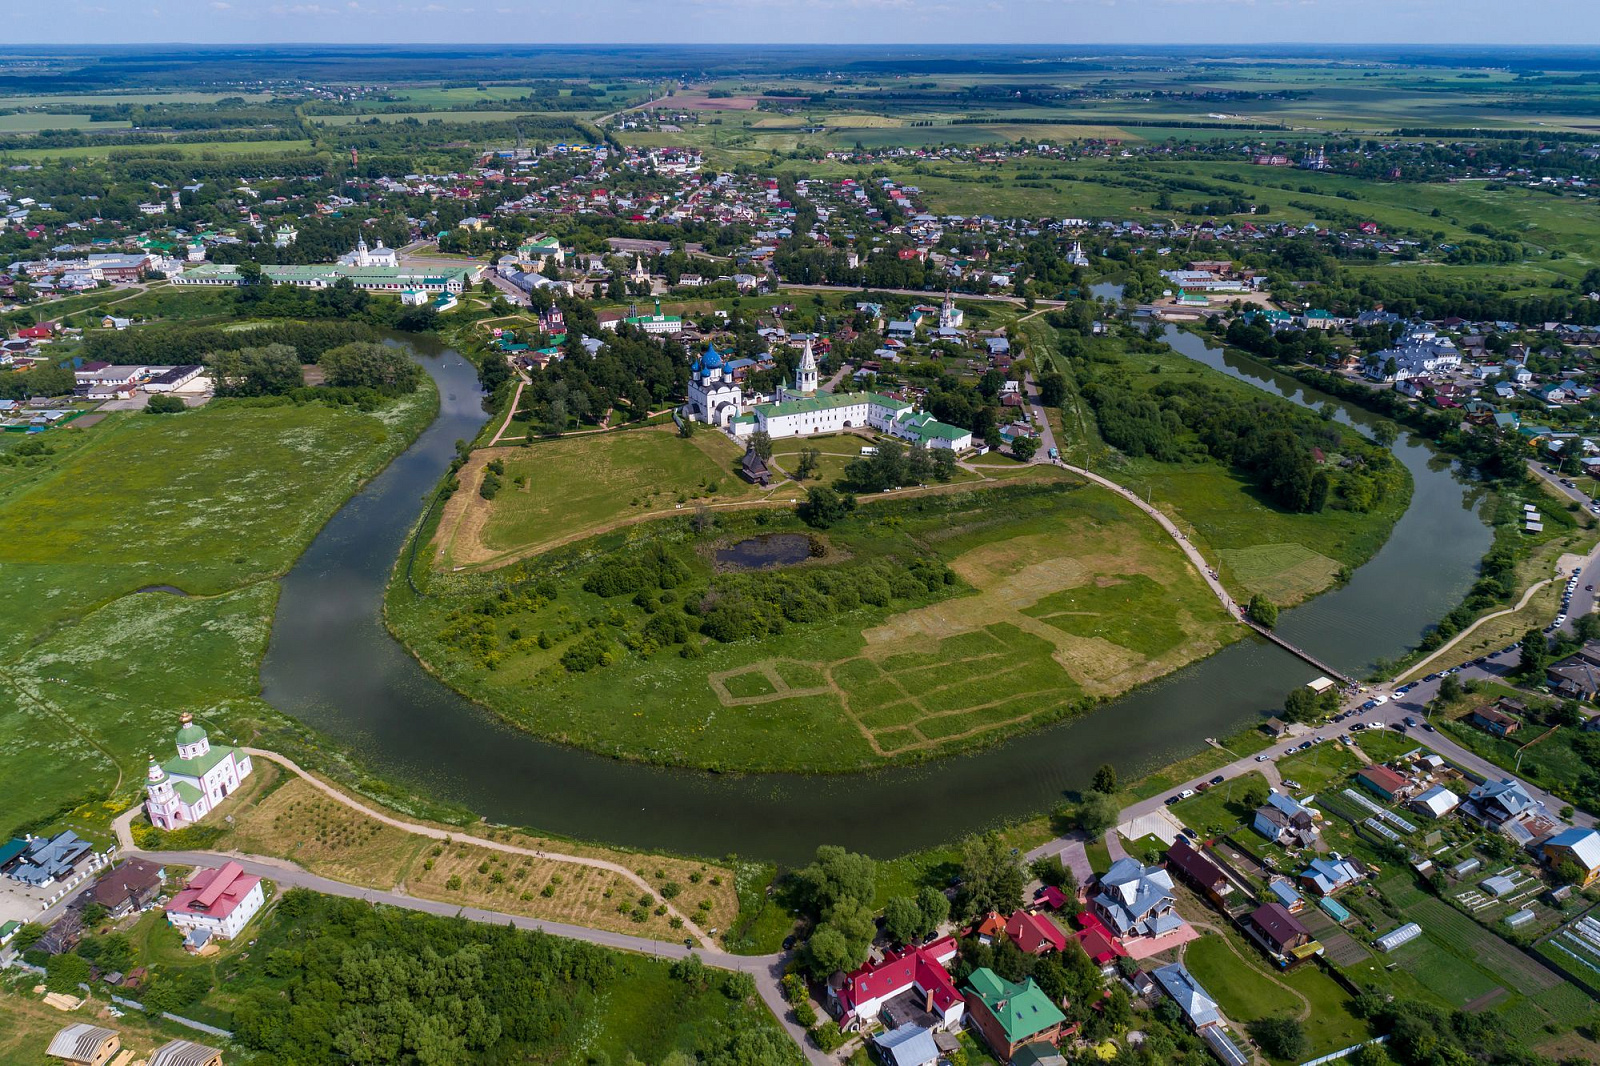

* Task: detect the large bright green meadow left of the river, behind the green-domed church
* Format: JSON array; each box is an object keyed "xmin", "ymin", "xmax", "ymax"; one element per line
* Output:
[{"xmin": 0, "ymin": 386, "xmax": 435, "ymax": 831}]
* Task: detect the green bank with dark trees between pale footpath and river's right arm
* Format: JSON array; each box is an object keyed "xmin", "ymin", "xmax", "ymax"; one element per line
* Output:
[{"xmin": 1054, "ymin": 314, "xmax": 1411, "ymax": 607}]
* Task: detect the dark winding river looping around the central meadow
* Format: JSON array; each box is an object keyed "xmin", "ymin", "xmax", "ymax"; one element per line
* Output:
[{"xmin": 261, "ymin": 326, "xmax": 1491, "ymax": 864}]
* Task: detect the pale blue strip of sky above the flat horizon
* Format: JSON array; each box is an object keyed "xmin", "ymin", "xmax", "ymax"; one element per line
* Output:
[{"xmin": 18, "ymin": 0, "xmax": 1600, "ymax": 50}]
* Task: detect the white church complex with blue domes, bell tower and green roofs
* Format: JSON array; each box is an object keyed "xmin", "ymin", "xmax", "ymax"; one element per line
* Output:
[{"xmin": 682, "ymin": 339, "xmax": 973, "ymax": 451}]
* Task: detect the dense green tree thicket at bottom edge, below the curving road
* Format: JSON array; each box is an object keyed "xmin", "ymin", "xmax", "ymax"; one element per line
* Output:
[{"xmin": 227, "ymin": 890, "xmax": 800, "ymax": 1066}]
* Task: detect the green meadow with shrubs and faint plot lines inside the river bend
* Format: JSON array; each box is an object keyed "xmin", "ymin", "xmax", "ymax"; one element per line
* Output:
[{"xmin": 386, "ymin": 467, "xmax": 1234, "ymax": 771}]
